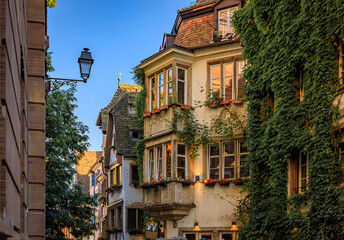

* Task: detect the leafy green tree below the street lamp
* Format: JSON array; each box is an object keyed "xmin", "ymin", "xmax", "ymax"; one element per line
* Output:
[{"xmin": 46, "ymin": 89, "xmax": 97, "ymax": 239}]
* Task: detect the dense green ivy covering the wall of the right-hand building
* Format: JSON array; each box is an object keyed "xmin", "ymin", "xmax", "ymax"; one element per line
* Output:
[{"xmin": 233, "ymin": 0, "xmax": 344, "ymax": 240}]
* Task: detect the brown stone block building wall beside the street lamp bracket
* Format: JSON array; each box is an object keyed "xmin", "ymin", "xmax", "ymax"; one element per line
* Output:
[{"xmin": 0, "ymin": 0, "xmax": 48, "ymax": 240}]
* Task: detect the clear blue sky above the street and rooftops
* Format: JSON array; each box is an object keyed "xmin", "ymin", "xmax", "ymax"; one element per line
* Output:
[{"xmin": 48, "ymin": 0, "xmax": 192, "ymax": 151}]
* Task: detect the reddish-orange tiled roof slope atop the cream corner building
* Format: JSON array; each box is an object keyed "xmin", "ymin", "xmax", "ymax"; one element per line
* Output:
[{"xmin": 174, "ymin": 14, "xmax": 215, "ymax": 48}]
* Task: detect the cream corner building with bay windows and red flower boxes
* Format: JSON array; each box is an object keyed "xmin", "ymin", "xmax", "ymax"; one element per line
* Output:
[{"xmin": 138, "ymin": 0, "xmax": 249, "ymax": 240}]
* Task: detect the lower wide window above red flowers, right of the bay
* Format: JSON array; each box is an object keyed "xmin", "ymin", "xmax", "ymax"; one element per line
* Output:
[{"xmin": 207, "ymin": 140, "xmax": 250, "ymax": 179}]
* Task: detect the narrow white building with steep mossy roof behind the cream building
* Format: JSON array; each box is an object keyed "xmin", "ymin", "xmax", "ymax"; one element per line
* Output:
[{"xmin": 93, "ymin": 84, "xmax": 143, "ymax": 239}]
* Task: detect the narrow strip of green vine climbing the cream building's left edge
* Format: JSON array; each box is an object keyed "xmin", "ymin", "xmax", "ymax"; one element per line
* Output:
[{"xmin": 133, "ymin": 68, "xmax": 146, "ymax": 183}]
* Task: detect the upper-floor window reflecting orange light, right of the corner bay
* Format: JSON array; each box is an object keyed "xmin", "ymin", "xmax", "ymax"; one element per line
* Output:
[{"xmin": 210, "ymin": 60, "xmax": 246, "ymax": 100}]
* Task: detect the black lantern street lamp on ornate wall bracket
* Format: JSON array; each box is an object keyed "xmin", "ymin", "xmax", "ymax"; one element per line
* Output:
[{"xmin": 45, "ymin": 48, "xmax": 94, "ymax": 93}]
